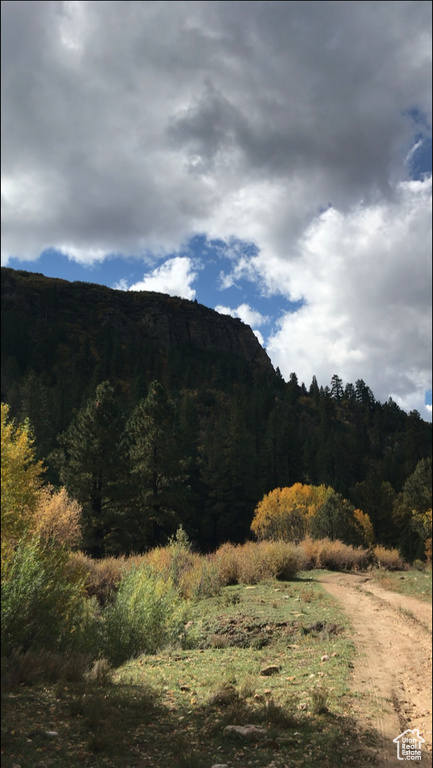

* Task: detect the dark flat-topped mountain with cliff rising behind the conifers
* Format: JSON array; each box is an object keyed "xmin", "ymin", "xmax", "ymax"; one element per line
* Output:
[{"xmin": 1, "ymin": 268, "xmax": 276, "ymax": 442}]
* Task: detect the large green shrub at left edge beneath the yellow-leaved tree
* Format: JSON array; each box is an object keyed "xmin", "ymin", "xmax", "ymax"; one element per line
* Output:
[{"xmin": 1, "ymin": 538, "xmax": 96, "ymax": 656}]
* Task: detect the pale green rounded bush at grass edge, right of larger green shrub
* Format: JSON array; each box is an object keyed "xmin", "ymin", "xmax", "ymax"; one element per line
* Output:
[{"xmin": 103, "ymin": 564, "xmax": 190, "ymax": 666}]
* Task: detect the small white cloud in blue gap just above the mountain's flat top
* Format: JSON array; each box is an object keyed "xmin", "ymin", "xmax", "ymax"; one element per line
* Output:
[{"xmin": 119, "ymin": 256, "xmax": 197, "ymax": 300}]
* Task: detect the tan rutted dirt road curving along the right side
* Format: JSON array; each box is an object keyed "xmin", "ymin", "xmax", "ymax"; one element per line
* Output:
[{"xmin": 319, "ymin": 573, "xmax": 432, "ymax": 768}]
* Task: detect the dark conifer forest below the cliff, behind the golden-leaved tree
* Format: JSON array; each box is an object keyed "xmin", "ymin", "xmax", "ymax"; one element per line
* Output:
[{"xmin": 22, "ymin": 376, "xmax": 431, "ymax": 559}]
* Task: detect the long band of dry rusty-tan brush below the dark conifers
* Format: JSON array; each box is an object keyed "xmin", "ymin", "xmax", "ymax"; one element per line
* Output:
[{"xmin": 69, "ymin": 532, "xmax": 408, "ymax": 605}]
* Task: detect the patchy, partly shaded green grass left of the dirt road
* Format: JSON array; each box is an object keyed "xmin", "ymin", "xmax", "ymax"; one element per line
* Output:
[{"xmin": 2, "ymin": 572, "xmax": 384, "ymax": 768}]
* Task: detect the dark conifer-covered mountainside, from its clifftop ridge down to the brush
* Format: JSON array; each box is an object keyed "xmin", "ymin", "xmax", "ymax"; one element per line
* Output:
[{"xmin": 2, "ymin": 269, "xmax": 431, "ymax": 559}]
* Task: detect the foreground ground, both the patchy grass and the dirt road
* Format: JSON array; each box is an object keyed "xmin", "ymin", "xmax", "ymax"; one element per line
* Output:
[{"xmin": 1, "ymin": 570, "xmax": 432, "ymax": 768}]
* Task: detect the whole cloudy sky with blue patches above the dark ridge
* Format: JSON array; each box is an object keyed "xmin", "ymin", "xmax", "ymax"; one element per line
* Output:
[{"xmin": 1, "ymin": 0, "xmax": 432, "ymax": 420}]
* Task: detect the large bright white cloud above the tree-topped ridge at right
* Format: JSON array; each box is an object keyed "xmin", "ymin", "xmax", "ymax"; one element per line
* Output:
[{"xmin": 264, "ymin": 179, "xmax": 431, "ymax": 411}]
